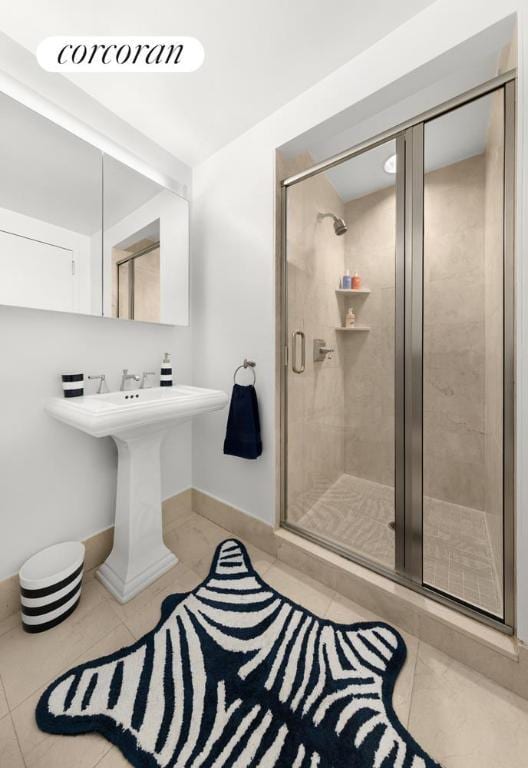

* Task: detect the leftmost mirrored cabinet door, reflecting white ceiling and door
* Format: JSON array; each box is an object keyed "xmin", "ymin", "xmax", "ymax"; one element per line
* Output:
[{"xmin": 0, "ymin": 94, "xmax": 102, "ymax": 315}]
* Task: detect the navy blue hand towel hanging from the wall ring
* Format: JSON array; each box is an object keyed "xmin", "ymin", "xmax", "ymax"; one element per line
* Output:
[{"xmin": 224, "ymin": 384, "xmax": 262, "ymax": 459}]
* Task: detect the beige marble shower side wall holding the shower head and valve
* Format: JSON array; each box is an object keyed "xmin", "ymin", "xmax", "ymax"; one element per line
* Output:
[{"xmin": 280, "ymin": 156, "xmax": 344, "ymax": 519}]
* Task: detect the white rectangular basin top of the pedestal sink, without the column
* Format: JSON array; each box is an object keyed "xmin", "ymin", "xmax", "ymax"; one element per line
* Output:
[{"xmin": 46, "ymin": 385, "xmax": 227, "ymax": 437}]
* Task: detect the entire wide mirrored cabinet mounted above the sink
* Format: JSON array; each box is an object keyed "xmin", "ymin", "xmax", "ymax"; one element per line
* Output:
[{"xmin": 0, "ymin": 94, "xmax": 189, "ymax": 325}]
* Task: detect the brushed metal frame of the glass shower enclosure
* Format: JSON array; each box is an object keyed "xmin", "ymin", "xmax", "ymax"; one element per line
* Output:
[{"xmin": 277, "ymin": 70, "xmax": 516, "ymax": 634}]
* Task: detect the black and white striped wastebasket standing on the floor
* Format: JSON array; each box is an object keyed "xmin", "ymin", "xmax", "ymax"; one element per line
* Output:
[{"xmin": 18, "ymin": 541, "xmax": 84, "ymax": 632}]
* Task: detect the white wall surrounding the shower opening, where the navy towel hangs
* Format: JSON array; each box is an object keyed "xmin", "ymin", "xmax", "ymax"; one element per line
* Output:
[{"xmin": 191, "ymin": 0, "xmax": 528, "ymax": 640}]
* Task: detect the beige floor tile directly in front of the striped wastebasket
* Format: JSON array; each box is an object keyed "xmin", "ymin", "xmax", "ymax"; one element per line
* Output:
[{"xmin": 0, "ymin": 581, "xmax": 119, "ymax": 709}]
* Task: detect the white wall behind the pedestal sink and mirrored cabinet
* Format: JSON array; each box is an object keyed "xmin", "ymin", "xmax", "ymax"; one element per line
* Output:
[{"xmin": 0, "ymin": 41, "xmax": 192, "ymax": 579}]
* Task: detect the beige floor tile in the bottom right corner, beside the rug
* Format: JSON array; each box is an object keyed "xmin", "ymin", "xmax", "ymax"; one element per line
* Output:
[{"xmin": 409, "ymin": 643, "xmax": 528, "ymax": 768}]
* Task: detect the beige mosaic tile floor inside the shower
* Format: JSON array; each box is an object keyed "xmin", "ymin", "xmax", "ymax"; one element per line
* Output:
[{"xmin": 293, "ymin": 474, "xmax": 502, "ymax": 616}]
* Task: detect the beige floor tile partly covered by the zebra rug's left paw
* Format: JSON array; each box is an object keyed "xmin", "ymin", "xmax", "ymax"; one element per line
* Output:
[{"xmin": 12, "ymin": 624, "xmax": 134, "ymax": 768}]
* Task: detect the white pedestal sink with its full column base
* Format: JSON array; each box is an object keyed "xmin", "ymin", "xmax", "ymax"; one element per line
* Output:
[{"xmin": 46, "ymin": 386, "xmax": 227, "ymax": 603}]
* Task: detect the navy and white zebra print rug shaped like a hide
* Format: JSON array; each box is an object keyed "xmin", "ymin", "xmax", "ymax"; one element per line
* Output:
[{"xmin": 36, "ymin": 539, "xmax": 438, "ymax": 768}]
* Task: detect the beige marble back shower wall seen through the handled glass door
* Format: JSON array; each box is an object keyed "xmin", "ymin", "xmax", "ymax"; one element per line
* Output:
[{"xmin": 339, "ymin": 186, "xmax": 396, "ymax": 486}]
